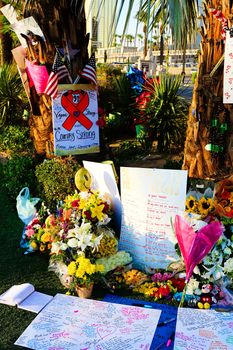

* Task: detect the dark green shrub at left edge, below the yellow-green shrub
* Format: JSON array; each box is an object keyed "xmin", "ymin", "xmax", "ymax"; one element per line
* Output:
[{"xmin": 2, "ymin": 155, "xmax": 37, "ymax": 200}]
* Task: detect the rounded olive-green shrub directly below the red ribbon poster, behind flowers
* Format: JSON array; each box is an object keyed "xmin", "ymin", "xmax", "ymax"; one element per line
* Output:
[{"xmin": 35, "ymin": 157, "xmax": 80, "ymax": 211}]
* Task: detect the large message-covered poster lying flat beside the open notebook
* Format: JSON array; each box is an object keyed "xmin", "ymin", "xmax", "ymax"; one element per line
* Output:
[{"xmin": 15, "ymin": 294, "xmax": 161, "ymax": 350}]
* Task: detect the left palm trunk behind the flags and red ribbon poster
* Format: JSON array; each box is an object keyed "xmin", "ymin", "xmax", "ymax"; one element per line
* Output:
[{"xmin": 15, "ymin": 0, "xmax": 89, "ymax": 157}]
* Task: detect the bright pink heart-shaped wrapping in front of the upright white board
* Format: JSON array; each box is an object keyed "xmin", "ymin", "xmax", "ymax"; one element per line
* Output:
[{"xmin": 174, "ymin": 215, "xmax": 224, "ymax": 281}]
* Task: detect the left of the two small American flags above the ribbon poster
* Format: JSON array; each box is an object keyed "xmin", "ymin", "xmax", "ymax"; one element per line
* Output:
[{"xmin": 44, "ymin": 52, "xmax": 72, "ymax": 98}]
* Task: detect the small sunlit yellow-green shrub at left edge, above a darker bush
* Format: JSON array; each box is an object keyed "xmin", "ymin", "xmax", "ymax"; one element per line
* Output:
[{"xmin": 0, "ymin": 125, "xmax": 33, "ymax": 153}]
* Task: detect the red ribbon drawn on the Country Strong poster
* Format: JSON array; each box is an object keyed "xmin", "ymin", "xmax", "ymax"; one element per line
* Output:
[{"xmin": 61, "ymin": 90, "xmax": 93, "ymax": 131}]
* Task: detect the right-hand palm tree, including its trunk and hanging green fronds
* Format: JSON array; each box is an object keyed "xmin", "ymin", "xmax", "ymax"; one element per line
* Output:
[{"xmin": 137, "ymin": 0, "xmax": 233, "ymax": 178}]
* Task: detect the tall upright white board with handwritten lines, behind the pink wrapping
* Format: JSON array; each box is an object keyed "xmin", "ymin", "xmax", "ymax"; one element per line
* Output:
[{"xmin": 119, "ymin": 167, "xmax": 187, "ymax": 270}]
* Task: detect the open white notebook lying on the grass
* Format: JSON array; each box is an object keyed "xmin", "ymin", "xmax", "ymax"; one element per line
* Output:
[{"xmin": 0, "ymin": 283, "xmax": 53, "ymax": 313}]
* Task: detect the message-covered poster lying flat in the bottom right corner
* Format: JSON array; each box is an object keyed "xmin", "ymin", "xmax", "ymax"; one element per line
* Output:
[{"xmin": 174, "ymin": 308, "xmax": 233, "ymax": 350}]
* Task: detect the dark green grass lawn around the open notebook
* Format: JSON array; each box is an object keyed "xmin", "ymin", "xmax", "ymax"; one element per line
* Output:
[{"xmin": 0, "ymin": 185, "xmax": 65, "ymax": 350}]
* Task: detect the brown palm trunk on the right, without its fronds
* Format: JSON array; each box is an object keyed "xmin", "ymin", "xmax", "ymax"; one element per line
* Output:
[{"xmin": 182, "ymin": 0, "xmax": 233, "ymax": 179}]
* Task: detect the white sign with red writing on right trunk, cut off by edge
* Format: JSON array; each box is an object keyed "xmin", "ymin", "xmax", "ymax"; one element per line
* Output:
[{"xmin": 223, "ymin": 31, "xmax": 233, "ymax": 103}]
